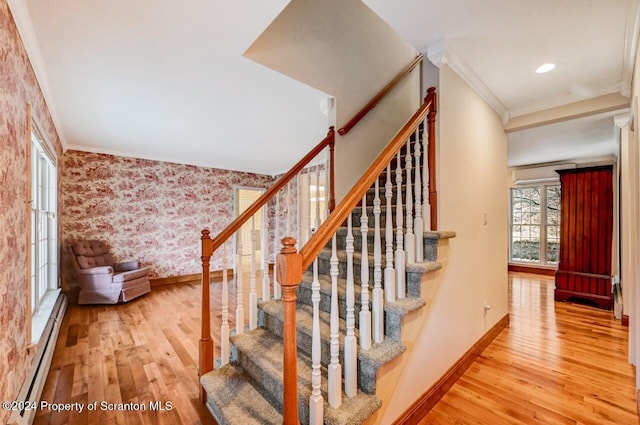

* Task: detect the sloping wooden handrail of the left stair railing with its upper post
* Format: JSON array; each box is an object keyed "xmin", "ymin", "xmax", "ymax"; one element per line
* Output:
[{"xmin": 202, "ymin": 127, "xmax": 335, "ymax": 256}]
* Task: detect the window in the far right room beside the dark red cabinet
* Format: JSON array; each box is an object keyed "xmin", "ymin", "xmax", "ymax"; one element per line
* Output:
[{"xmin": 510, "ymin": 185, "xmax": 560, "ymax": 265}]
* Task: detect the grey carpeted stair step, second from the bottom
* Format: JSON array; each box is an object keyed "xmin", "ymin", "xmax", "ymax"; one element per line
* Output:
[{"xmin": 231, "ymin": 328, "xmax": 382, "ymax": 425}]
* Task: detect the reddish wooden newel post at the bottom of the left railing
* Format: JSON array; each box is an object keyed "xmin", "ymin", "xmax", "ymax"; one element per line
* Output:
[{"xmin": 198, "ymin": 229, "xmax": 213, "ymax": 403}]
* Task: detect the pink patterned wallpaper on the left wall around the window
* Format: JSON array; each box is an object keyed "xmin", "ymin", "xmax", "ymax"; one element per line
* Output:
[{"xmin": 0, "ymin": 0, "xmax": 62, "ymax": 423}]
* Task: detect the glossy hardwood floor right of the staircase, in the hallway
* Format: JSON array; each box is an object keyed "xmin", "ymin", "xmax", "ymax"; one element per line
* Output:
[{"xmin": 420, "ymin": 273, "xmax": 639, "ymax": 425}]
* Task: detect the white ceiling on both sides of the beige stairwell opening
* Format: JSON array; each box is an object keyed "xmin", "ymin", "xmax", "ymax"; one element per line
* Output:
[{"xmin": 9, "ymin": 0, "xmax": 638, "ymax": 174}]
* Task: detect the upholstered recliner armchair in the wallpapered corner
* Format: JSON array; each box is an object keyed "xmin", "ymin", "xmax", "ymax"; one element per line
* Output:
[{"xmin": 67, "ymin": 240, "xmax": 151, "ymax": 304}]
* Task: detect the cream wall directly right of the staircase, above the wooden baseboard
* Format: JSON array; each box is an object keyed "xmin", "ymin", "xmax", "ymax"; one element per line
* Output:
[{"xmin": 382, "ymin": 65, "xmax": 508, "ymax": 423}]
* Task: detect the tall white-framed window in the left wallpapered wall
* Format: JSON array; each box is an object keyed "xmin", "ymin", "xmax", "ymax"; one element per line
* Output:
[{"xmin": 31, "ymin": 133, "xmax": 58, "ymax": 315}]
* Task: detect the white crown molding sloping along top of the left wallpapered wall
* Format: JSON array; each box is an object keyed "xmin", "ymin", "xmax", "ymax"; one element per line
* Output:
[{"xmin": 7, "ymin": 0, "xmax": 67, "ymax": 151}]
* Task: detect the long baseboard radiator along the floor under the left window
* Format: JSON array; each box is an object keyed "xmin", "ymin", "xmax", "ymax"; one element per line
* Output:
[{"xmin": 7, "ymin": 293, "xmax": 67, "ymax": 425}]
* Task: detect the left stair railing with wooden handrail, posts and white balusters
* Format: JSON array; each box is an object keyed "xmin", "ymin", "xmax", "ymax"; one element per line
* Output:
[{"xmin": 198, "ymin": 127, "xmax": 335, "ymax": 403}]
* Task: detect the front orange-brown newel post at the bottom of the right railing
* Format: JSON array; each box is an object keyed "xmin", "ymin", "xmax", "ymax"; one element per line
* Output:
[{"xmin": 276, "ymin": 237, "xmax": 302, "ymax": 425}]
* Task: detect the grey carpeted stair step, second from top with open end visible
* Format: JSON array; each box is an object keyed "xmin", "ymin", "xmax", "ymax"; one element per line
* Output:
[{"xmin": 309, "ymin": 248, "xmax": 442, "ymax": 297}]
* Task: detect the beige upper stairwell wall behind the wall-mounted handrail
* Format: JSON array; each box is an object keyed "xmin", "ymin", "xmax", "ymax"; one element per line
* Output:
[{"xmin": 245, "ymin": 0, "xmax": 425, "ymax": 201}]
